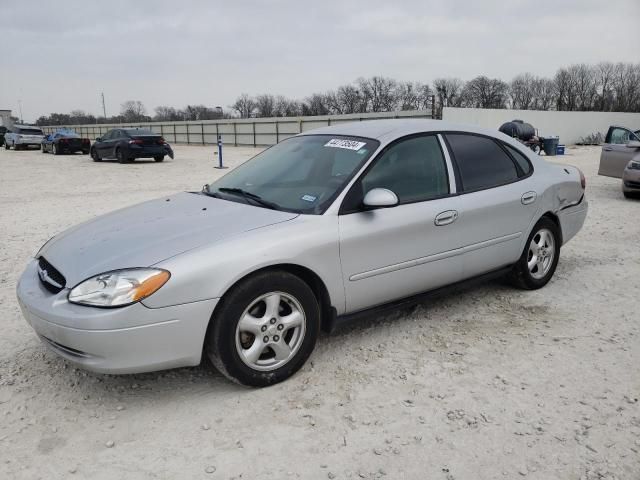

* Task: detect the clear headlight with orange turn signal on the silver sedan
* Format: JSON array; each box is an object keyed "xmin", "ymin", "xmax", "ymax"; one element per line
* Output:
[{"xmin": 68, "ymin": 268, "xmax": 171, "ymax": 307}]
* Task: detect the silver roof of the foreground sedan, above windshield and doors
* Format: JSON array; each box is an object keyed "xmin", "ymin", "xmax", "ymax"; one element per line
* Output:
[{"xmin": 301, "ymin": 118, "xmax": 509, "ymax": 144}]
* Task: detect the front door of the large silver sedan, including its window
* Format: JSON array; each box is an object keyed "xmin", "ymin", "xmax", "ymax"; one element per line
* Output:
[{"xmin": 339, "ymin": 135, "xmax": 463, "ymax": 312}]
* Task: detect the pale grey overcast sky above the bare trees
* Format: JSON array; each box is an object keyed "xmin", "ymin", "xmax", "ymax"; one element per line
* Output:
[{"xmin": 0, "ymin": 0, "xmax": 640, "ymax": 121}]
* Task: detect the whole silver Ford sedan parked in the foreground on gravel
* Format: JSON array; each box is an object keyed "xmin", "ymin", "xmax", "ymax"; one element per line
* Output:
[{"xmin": 17, "ymin": 120, "xmax": 587, "ymax": 386}]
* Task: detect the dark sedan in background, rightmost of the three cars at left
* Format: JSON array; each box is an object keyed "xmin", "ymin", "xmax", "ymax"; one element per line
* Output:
[{"xmin": 91, "ymin": 128, "xmax": 173, "ymax": 163}]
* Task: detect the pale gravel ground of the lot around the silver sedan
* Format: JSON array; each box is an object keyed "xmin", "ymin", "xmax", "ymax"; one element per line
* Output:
[{"xmin": 0, "ymin": 146, "xmax": 640, "ymax": 480}]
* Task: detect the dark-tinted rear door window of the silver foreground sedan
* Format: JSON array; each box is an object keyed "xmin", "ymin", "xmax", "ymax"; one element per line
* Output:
[{"xmin": 446, "ymin": 133, "xmax": 518, "ymax": 192}]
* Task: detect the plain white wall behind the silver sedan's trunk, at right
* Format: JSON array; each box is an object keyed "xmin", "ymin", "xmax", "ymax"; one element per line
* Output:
[{"xmin": 442, "ymin": 107, "xmax": 640, "ymax": 145}]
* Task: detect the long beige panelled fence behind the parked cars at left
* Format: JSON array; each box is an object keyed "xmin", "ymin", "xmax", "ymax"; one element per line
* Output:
[{"xmin": 42, "ymin": 110, "xmax": 432, "ymax": 146}]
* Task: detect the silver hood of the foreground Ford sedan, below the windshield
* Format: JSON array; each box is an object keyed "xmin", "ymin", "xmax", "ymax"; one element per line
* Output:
[{"xmin": 38, "ymin": 192, "xmax": 298, "ymax": 287}]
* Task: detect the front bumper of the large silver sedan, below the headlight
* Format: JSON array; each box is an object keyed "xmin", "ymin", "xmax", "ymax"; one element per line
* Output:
[{"xmin": 17, "ymin": 261, "xmax": 218, "ymax": 373}]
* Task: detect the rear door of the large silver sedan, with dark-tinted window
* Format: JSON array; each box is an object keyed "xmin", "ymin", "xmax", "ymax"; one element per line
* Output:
[{"xmin": 445, "ymin": 133, "xmax": 538, "ymax": 278}]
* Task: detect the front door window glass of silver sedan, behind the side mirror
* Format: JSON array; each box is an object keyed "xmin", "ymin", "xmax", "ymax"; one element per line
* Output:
[{"xmin": 361, "ymin": 135, "xmax": 449, "ymax": 204}]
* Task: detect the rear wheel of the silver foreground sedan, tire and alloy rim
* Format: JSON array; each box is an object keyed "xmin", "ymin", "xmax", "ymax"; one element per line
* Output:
[{"xmin": 509, "ymin": 217, "xmax": 561, "ymax": 290}]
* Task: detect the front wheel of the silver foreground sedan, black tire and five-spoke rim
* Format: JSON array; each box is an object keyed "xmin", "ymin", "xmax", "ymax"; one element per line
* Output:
[{"xmin": 205, "ymin": 271, "xmax": 320, "ymax": 387}]
